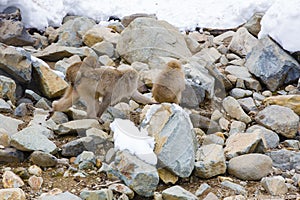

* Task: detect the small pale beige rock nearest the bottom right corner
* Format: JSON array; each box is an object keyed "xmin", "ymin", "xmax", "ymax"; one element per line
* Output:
[{"xmin": 261, "ymin": 176, "xmax": 288, "ymax": 196}]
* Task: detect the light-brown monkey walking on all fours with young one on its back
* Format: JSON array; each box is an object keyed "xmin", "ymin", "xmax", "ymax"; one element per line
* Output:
[{"xmin": 48, "ymin": 56, "xmax": 155, "ymax": 118}]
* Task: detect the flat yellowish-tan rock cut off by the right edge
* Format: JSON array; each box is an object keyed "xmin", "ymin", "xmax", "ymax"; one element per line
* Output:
[{"xmin": 263, "ymin": 95, "xmax": 300, "ymax": 115}]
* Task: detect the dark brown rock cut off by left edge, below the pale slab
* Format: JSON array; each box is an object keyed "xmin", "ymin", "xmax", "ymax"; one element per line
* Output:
[{"xmin": 0, "ymin": 148, "xmax": 25, "ymax": 163}]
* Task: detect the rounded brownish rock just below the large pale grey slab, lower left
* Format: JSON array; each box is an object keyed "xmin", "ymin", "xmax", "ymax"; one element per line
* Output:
[{"xmin": 30, "ymin": 151, "xmax": 57, "ymax": 167}]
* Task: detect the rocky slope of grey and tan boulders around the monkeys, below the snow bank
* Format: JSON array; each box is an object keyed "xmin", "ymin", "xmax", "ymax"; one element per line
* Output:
[{"xmin": 0, "ymin": 9, "xmax": 300, "ymax": 200}]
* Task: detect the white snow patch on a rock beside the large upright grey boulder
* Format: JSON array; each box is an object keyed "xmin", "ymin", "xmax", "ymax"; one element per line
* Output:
[{"xmin": 110, "ymin": 118, "xmax": 157, "ymax": 165}]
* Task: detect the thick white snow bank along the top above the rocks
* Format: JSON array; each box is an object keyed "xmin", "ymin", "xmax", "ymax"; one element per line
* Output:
[{"xmin": 0, "ymin": 0, "xmax": 300, "ymax": 52}]
